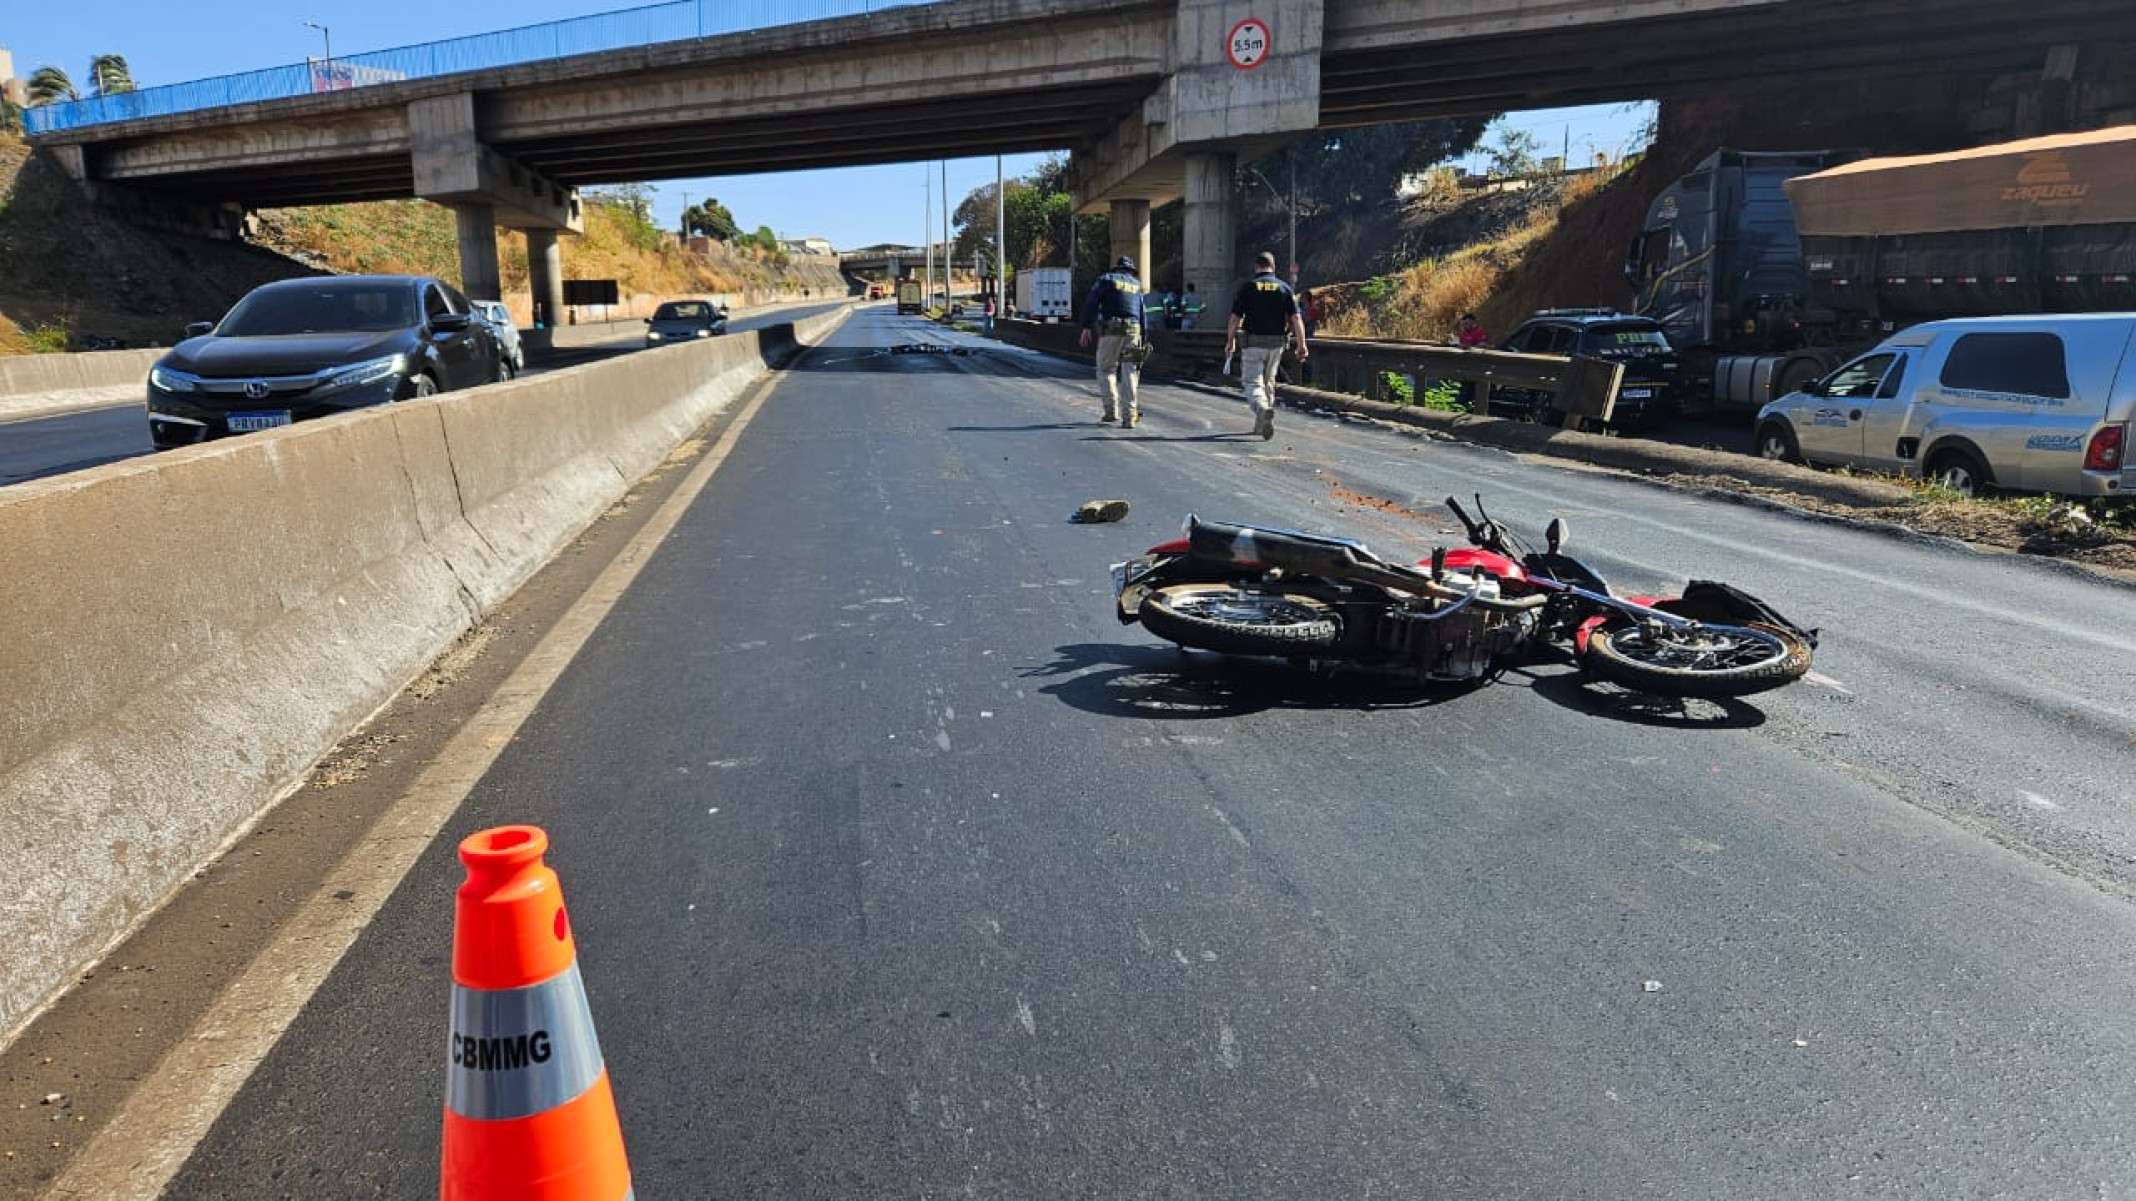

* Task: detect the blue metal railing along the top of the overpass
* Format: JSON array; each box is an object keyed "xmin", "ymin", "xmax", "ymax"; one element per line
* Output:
[{"xmin": 23, "ymin": 0, "xmax": 929, "ymax": 135}]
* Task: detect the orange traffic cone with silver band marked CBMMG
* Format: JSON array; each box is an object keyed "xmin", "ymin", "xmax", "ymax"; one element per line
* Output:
[{"xmin": 438, "ymin": 825, "xmax": 630, "ymax": 1201}]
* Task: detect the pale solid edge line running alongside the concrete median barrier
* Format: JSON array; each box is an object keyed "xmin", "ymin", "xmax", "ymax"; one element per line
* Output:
[{"xmin": 43, "ymin": 341, "xmax": 807, "ymax": 1201}]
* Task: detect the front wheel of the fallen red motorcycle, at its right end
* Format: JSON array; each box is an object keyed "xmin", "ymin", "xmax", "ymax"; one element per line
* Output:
[{"xmin": 1581, "ymin": 622, "xmax": 1809, "ymax": 699}]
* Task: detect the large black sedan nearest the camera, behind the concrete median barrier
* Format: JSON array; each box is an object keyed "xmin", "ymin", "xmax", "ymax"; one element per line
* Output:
[{"xmin": 147, "ymin": 276, "xmax": 502, "ymax": 449}]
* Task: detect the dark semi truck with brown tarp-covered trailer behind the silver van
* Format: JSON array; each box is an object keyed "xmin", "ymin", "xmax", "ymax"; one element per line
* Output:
[{"xmin": 1625, "ymin": 126, "xmax": 2136, "ymax": 410}]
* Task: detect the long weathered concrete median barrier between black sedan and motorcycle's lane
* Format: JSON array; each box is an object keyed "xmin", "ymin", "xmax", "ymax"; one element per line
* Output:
[{"xmin": 0, "ymin": 303, "xmax": 846, "ymax": 1032}]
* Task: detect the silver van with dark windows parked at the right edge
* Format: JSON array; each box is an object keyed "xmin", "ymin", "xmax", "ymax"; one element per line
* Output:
[{"xmin": 1756, "ymin": 312, "xmax": 2136, "ymax": 496}]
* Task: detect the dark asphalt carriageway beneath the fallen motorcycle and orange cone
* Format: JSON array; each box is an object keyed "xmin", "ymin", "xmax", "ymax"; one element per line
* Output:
[{"xmin": 71, "ymin": 310, "xmax": 2136, "ymax": 1199}]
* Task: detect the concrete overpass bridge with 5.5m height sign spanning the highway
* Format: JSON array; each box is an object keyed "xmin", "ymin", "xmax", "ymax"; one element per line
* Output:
[{"xmin": 32, "ymin": 0, "xmax": 2127, "ymax": 322}]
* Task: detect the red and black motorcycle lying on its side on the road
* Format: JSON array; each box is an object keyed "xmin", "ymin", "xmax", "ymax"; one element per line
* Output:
[{"xmin": 1113, "ymin": 496, "xmax": 1818, "ymax": 697}]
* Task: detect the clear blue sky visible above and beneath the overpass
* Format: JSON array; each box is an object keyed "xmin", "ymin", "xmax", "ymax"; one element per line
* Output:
[{"xmin": 0, "ymin": 0, "xmax": 1651, "ymax": 248}]
